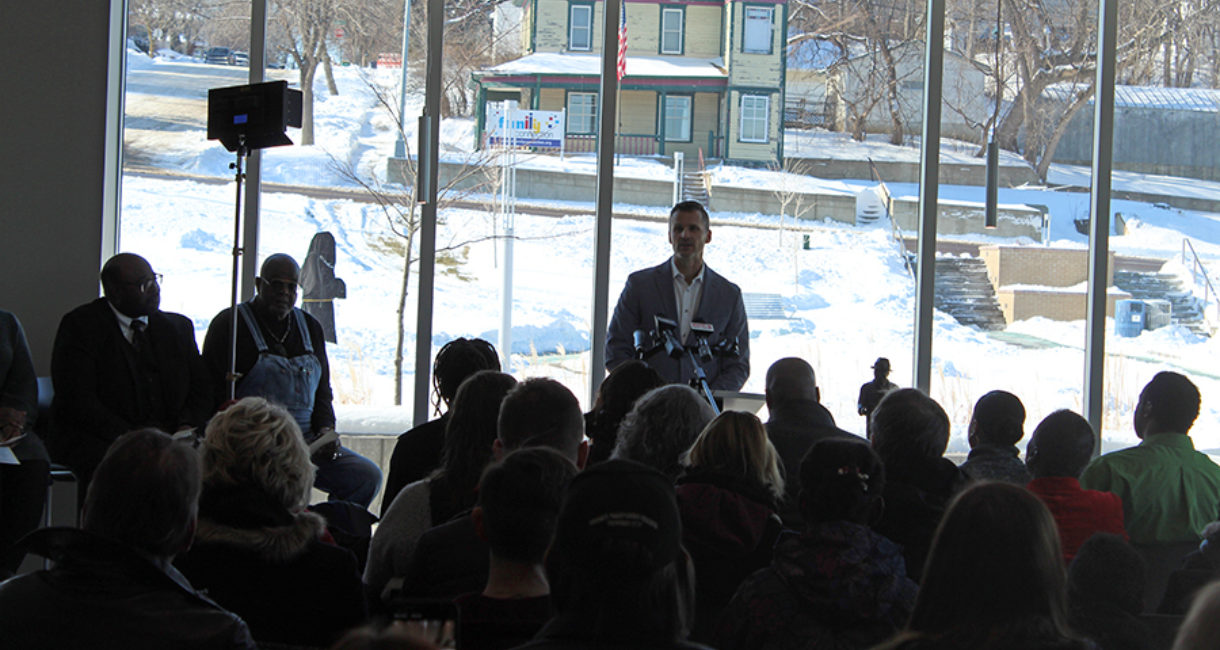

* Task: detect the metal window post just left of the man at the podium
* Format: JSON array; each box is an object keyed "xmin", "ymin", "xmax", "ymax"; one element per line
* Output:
[{"xmin": 589, "ymin": 0, "xmax": 622, "ymax": 404}]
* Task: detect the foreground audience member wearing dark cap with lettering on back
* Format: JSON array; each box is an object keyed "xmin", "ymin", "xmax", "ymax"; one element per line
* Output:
[{"xmin": 520, "ymin": 459, "xmax": 704, "ymax": 650}]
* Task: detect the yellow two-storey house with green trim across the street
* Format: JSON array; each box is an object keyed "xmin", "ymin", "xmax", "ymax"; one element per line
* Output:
[{"xmin": 473, "ymin": 0, "xmax": 788, "ymax": 163}]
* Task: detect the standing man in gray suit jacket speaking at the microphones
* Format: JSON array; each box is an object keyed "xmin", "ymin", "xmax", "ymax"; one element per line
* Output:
[{"xmin": 606, "ymin": 201, "xmax": 750, "ymax": 390}]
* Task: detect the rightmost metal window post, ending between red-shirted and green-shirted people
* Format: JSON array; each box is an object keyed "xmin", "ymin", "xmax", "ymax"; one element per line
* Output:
[{"xmin": 1083, "ymin": 0, "xmax": 1119, "ymax": 454}]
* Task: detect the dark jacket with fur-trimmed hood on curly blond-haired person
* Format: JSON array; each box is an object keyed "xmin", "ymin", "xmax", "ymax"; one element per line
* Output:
[{"xmin": 177, "ymin": 488, "xmax": 367, "ymax": 646}]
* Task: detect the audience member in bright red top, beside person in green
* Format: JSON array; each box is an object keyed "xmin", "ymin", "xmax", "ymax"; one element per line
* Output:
[{"xmin": 1025, "ymin": 410, "xmax": 1127, "ymax": 563}]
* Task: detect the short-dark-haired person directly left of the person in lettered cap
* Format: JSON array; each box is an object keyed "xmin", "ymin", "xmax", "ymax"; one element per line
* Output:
[{"xmin": 454, "ymin": 448, "xmax": 577, "ymax": 650}]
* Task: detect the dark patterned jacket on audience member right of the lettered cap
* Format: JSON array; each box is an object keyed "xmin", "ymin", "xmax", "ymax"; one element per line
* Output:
[{"xmin": 714, "ymin": 521, "xmax": 917, "ymax": 650}]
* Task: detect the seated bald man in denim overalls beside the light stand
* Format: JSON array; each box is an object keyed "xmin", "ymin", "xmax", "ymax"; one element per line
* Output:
[{"xmin": 204, "ymin": 254, "xmax": 381, "ymax": 507}]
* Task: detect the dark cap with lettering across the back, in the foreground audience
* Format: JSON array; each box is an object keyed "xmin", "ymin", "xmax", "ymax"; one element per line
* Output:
[{"xmin": 555, "ymin": 460, "xmax": 682, "ymax": 571}]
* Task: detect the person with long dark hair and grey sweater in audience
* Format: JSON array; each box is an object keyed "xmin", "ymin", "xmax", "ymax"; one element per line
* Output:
[{"xmin": 365, "ymin": 371, "xmax": 517, "ymax": 595}]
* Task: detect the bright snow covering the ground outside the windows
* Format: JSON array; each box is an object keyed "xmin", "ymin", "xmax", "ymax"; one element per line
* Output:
[{"xmin": 121, "ymin": 59, "xmax": 1220, "ymax": 451}]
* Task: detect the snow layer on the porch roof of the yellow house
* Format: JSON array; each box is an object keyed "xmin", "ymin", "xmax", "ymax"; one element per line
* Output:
[{"xmin": 483, "ymin": 52, "xmax": 728, "ymax": 78}]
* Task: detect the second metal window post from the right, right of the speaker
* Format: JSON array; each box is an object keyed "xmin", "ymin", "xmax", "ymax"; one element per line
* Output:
[{"xmin": 914, "ymin": 0, "xmax": 944, "ymax": 393}]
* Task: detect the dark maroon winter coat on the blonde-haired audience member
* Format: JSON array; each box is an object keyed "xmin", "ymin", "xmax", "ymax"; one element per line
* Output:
[{"xmin": 676, "ymin": 468, "xmax": 782, "ymax": 641}]
